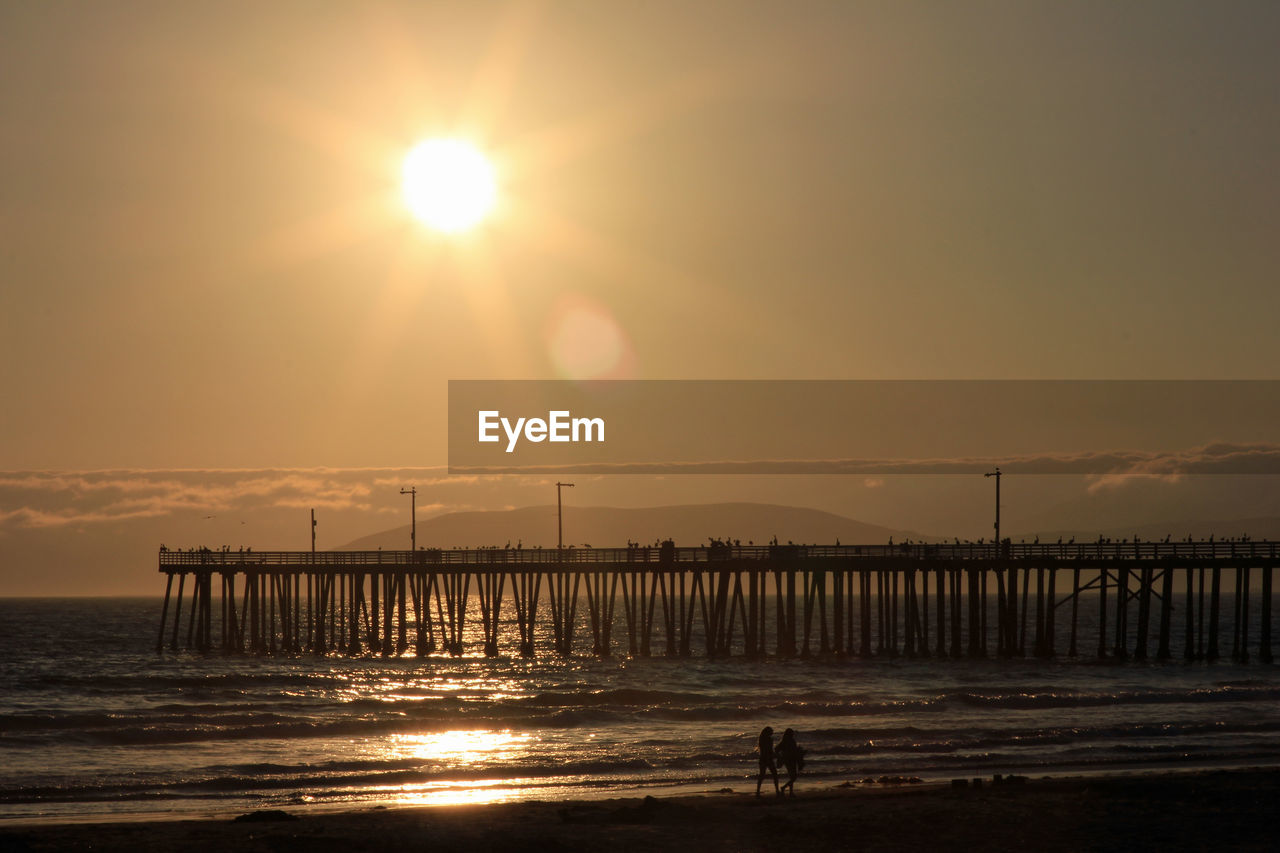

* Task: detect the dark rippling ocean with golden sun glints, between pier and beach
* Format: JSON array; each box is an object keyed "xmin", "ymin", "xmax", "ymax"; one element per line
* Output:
[{"xmin": 0, "ymin": 598, "xmax": 1280, "ymax": 821}]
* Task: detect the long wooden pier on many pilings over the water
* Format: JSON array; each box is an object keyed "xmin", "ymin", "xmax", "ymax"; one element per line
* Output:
[{"xmin": 156, "ymin": 540, "xmax": 1280, "ymax": 662}]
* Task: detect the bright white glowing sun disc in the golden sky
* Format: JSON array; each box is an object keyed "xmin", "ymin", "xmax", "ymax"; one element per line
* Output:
[{"xmin": 401, "ymin": 140, "xmax": 498, "ymax": 234}]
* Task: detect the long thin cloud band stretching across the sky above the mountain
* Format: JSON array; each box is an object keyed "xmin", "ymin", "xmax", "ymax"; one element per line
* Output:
[{"xmin": 0, "ymin": 442, "xmax": 1280, "ymax": 532}]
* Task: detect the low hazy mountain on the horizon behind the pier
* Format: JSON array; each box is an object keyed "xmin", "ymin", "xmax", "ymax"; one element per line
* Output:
[{"xmin": 342, "ymin": 503, "xmax": 928, "ymax": 551}]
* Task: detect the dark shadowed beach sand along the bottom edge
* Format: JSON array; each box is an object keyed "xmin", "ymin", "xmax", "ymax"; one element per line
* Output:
[{"xmin": 0, "ymin": 770, "xmax": 1280, "ymax": 853}]
